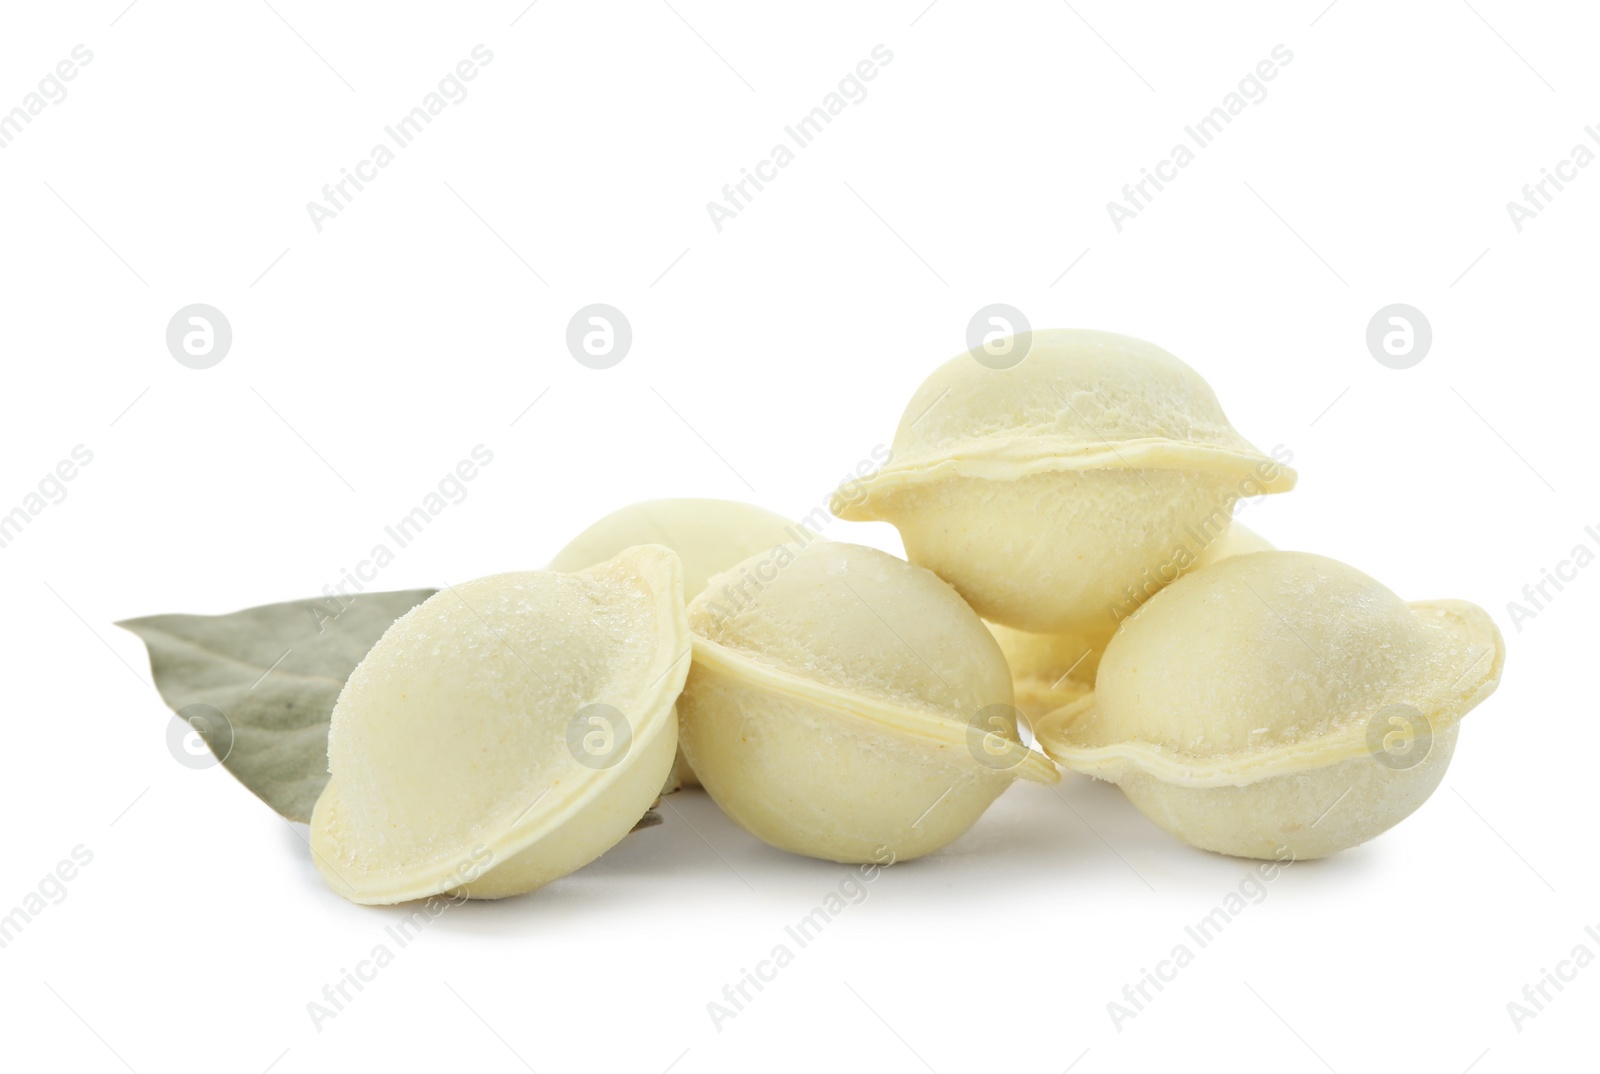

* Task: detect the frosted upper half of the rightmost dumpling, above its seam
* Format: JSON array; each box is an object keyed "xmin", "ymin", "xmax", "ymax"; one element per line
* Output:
[{"xmin": 1094, "ymin": 552, "xmax": 1491, "ymax": 759}]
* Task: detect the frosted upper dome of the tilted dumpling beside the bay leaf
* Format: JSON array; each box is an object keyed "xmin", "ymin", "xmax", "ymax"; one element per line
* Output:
[{"xmin": 328, "ymin": 553, "xmax": 678, "ymax": 872}]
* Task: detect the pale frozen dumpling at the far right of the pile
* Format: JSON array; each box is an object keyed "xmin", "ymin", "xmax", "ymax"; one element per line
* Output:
[{"xmin": 1035, "ymin": 552, "xmax": 1506, "ymax": 860}]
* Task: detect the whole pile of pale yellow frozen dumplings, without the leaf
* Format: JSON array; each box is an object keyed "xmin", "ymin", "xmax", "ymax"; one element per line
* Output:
[{"xmin": 312, "ymin": 330, "xmax": 1506, "ymax": 903}]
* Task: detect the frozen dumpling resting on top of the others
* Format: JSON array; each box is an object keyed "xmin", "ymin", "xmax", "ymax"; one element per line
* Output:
[{"xmin": 834, "ymin": 330, "xmax": 1294, "ymax": 639}]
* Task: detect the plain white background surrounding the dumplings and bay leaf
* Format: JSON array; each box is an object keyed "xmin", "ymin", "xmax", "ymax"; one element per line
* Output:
[{"xmin": 0, "ymin": 0, "xmax": 1600, "ymax": 1074}]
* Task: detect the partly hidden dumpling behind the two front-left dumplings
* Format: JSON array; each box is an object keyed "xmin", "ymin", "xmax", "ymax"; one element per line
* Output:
[{"xmin": 550, "ymin": 499, "xmax": 806, "ymax": 791}]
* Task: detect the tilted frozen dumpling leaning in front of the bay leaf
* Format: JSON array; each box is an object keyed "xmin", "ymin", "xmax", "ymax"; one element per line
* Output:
[{"xmin": 310, "ymin": 546, "xmax": 690, "ymax": 903}]
